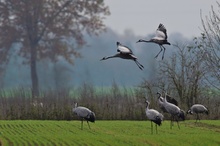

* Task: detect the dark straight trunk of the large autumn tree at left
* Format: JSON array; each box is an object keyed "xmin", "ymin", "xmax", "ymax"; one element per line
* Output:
[{"xmin": 30, "ymin": 45, "xmax": 39, "ymax": 98}]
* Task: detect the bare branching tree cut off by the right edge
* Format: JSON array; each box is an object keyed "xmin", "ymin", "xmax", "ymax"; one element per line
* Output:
[{"xmin": 201, "ymin": 2, "xmax": 220, "ymax": 89}]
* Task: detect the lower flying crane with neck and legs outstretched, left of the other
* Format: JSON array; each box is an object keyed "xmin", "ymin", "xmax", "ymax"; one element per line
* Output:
[{"xmin": 101, "ymin": 42, "xmax": 144, "ymax": 70}]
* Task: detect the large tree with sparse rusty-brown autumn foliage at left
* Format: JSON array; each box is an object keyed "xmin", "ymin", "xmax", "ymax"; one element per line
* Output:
[{"xmin": 0, "ymin": 0, "xmax": 110, "ymax": 96}]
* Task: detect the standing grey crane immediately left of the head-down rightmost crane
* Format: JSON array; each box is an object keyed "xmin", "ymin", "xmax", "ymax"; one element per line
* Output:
[{"xmin": 162, "ymin": 95, "xmax": 185, "ymax": 129}]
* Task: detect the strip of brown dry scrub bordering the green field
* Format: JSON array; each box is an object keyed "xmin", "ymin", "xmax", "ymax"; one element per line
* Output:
[{"xmin": 0, "ymin": 83, "xmax": 220, "ymax": 120}]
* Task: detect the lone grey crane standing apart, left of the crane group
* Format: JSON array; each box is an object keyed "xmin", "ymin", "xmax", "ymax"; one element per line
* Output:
[{"xmin": 73, "ymin": 103, "xmax": 95, "ymax": 129}]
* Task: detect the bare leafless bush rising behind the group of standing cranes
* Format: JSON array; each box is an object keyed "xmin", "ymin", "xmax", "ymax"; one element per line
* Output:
[{"xmin": 159, "ymin": 45, "xmax": 206, "ymax": 107}]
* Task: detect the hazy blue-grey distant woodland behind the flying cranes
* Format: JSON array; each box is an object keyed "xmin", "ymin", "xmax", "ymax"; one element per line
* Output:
[{"xmin": 1, "ymin": 28, "xmax": 192, "ymax": 88}]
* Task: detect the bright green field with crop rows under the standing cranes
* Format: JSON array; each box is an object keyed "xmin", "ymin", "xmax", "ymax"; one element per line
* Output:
[{"xmin": 0, "ymin": 120, "xmax": 220, "ymax": 146}]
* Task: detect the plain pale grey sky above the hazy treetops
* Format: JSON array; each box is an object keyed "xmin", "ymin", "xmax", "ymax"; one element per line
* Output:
[{"xmin": 105, "ymin": 0, "xmax": 217, "ymax": 38}]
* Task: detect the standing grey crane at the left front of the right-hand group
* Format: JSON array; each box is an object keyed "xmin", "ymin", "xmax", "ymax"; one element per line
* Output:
[{"xmin": 145, "ymin": 100, "xmax": 163, "ymax": 134}]
